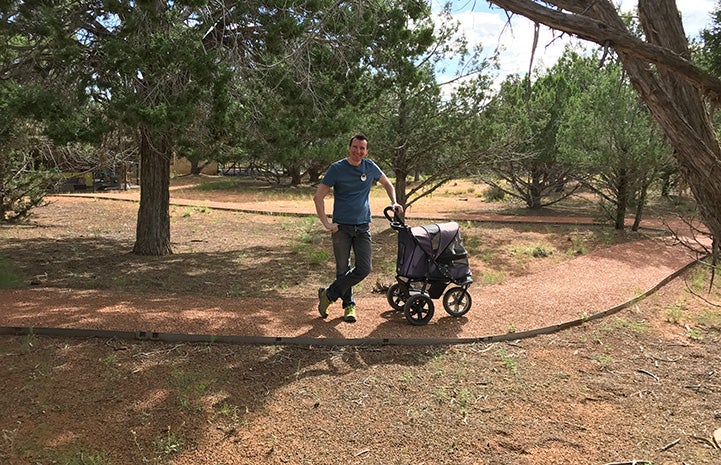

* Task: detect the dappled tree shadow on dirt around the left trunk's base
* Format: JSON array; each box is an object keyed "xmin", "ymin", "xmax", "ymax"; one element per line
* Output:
[{"xmin": 0, "ymin": 237, "xmax": 326, "ymax": 298}]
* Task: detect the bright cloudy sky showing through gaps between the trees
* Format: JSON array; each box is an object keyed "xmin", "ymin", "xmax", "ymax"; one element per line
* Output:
[{"xmin": 432, "ymin": 0, "xmax": 716, "ymax": 81}]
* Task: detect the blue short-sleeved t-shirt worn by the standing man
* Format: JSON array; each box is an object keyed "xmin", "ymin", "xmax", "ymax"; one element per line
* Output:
[{"xmin": 322, "ymin": 158, "xmax": 383, "ymax": 224}]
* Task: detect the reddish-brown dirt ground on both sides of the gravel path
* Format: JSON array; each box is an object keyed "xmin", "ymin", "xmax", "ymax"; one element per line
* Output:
[{"xmin": 0, "ymin": 176, "xmax": 721, "ymax": 465}]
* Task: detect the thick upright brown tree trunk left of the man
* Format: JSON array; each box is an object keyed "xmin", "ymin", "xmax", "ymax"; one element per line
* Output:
[{"xmin": 133, "ymin": 128, "xmax": 173, "ymax": 256}]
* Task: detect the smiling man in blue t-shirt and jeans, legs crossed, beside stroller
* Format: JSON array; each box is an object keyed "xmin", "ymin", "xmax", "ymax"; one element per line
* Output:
[{"xmin": 313, "ymin": 134, "xmax": 403, "ymax": 323}]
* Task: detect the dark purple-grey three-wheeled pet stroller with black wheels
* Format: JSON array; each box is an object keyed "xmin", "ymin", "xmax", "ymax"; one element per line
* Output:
[{"xmin": 383, "ymin": 207, "xmax": 473, "ymax": 325}]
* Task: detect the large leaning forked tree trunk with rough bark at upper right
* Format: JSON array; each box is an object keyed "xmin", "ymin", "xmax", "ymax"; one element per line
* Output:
[{"xmin": 489, "ymin": 0, "xmax": 721, "ymax": 243}]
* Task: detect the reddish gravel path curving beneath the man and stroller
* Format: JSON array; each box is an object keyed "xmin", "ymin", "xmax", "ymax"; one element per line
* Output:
[{"xmin": 0, "ymin": 193, "xmax": 694, "ymax": 341}]
